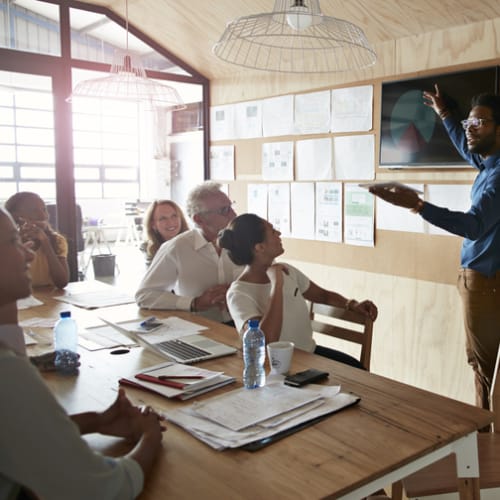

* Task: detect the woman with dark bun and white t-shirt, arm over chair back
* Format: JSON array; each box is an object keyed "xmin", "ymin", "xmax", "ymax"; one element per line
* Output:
[{"xmin": 219, "ymin": 214, "xmax": 377, "ymax": 368}]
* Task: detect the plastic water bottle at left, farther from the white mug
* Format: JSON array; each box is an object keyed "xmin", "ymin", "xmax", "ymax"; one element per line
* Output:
[{"xmin": 54, "ymin": 311, "xmax": 78, "ymax": 375}]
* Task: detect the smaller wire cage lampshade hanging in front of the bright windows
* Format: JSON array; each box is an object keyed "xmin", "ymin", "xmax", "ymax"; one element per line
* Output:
[{"xmin": 69, "ymin": 50, "xmax": 186, "ymax": 110}]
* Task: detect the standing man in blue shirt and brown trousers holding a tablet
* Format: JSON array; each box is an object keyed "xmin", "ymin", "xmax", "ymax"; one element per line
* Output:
[{"xmin": 370, "ymin": 85, "xmax": 500, "ymax": 409}]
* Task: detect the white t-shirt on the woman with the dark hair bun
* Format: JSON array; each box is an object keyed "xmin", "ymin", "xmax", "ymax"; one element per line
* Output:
[{"xmin": 227, "ymin": 264, "xmax": 316, "ymax": 352}]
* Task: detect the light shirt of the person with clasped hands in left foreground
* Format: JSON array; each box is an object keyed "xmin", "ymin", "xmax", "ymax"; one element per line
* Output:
[{"xmin": 0, "ymin": 336, "xmax": 144, "ymax": 500}]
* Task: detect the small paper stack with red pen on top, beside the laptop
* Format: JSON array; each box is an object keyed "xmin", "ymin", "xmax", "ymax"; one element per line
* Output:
[{"xmin": 120, "ymin": 362, "xmax": 235, "ymax": 400}]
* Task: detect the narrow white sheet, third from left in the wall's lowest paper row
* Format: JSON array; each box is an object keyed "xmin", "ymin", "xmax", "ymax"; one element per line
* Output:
[{"xmin": 290, "ymin": 182, "xmax": 314, "ymax": 240}]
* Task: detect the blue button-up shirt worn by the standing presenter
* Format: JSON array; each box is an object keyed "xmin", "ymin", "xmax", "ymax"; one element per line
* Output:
[{"xmin": 420, "ymin": 117, "xmax": 500, "ymax": 276}]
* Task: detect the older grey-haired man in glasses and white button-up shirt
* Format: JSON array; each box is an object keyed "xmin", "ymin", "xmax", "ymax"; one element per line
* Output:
[{"xmin": 135, "ymin": 181, "xmax": 242, "ymax": 323}]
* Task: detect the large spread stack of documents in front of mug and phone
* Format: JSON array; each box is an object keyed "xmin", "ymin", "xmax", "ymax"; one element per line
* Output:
[{"xmin": 165, "ymin": 382, "xmax": 359, "ymax": 450}]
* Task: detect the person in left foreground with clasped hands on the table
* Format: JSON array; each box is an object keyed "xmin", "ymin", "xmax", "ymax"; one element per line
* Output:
[{"xmin": 0, "ymin": 208, "xmax": 165, "ymax": 500}]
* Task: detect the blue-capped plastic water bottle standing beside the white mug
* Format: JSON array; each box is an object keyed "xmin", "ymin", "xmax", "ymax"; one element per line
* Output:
[{"xmin": 243, "ymin": 319, "xmax": 266, "ymax": 389}]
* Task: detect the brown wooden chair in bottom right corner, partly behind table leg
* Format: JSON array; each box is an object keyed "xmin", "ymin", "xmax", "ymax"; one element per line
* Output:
[{"xmin": 392, "ymin": 350, "xmax": 500, "ymax": 500}]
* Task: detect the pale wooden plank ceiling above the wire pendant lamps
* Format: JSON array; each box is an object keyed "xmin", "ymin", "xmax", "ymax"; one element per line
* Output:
[{"xmin": 77, "ymin": 0, "xmax": 500, "ymax": 80}]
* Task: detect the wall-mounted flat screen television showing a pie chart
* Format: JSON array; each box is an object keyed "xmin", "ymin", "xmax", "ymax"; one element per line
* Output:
[{"xmin": 379, "ymin": 66, "xmax": 499, "ymax": 168}]
